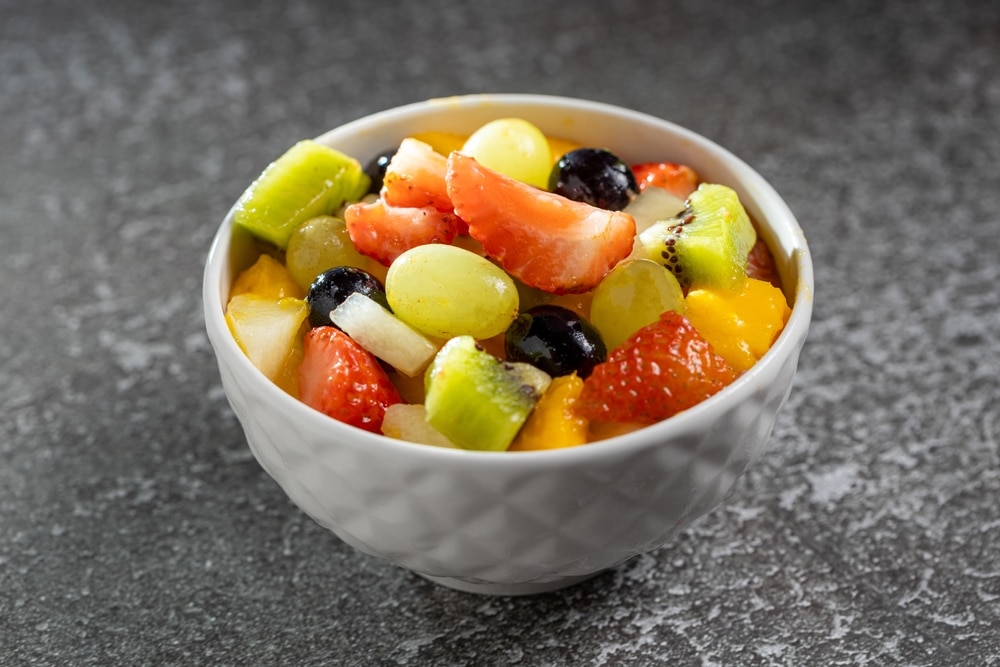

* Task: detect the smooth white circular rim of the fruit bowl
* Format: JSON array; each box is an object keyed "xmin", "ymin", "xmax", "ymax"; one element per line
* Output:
[{"xmin": 202, "ymin": 93, "xmax": 814, "ymax": 470}]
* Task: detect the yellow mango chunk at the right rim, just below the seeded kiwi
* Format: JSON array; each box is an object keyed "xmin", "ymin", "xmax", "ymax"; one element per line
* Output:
[{"xmin": 684, "ymin": 278, "xmax": 791, "ymax": 371}]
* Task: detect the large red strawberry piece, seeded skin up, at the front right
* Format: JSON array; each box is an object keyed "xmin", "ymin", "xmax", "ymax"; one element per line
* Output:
[{"xmin": 577, "ymin": 311, "xmax": 737, "ymax": 424}]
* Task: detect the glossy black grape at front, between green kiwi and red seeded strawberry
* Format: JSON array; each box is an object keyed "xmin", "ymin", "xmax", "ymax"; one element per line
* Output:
[{"xmin": 504, "ymin": 305, "xmax": 607, "ymax": 377}]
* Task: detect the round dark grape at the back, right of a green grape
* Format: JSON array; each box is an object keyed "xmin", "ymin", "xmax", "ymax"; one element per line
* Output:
[{"xmin": 548, "ymin": 148, "xmax": 639, "ymax": 211}]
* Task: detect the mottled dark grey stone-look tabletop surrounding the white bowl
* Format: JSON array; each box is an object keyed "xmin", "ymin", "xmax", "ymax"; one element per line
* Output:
[{"xmin": 0, "ymin": 0, "xmax": 1000, "ymax": 666}]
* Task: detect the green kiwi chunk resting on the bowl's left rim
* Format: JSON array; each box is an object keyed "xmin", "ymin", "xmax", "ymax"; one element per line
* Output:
[{"xmin": 233, "ymin": 139, "xmax": 369, "ymax": 249}]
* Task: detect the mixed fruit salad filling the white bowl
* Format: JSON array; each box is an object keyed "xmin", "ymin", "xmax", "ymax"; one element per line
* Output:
[{"xmin": 226, "ymin": 118, "xmax": 790, "ymax": 451}]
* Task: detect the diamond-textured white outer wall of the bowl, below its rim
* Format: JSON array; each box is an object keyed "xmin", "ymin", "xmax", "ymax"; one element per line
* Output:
[{"xmin": 213, "ymin": 340, "xmax": 794, "ymax": 586}]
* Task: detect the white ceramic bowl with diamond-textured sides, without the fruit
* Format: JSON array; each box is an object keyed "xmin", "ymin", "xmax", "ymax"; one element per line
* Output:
[{"xmin": 204, "ymin": 95, "xmax": 813, "ymax": 595}]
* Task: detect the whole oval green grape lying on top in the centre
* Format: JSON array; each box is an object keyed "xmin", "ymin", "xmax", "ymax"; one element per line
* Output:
[{"xmin": 385, "ymin": 243, "xmax": 518, "ymax": 339}]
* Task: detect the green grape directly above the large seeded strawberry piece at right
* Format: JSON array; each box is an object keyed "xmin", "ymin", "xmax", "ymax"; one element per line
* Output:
[{"xmin": 590, "ymin": 259, "xmax": 684, "ymax": 351}]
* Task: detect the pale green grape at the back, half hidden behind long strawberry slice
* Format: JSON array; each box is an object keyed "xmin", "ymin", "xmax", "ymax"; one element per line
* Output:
[{"xmin": 462, "ymin": 118, "xmax": 552, "ymax": 190}]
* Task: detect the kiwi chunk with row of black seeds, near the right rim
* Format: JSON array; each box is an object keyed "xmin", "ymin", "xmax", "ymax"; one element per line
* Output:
[{"xmin": 639, "ymin": 183, "xmax": 757, "ymax": 289}]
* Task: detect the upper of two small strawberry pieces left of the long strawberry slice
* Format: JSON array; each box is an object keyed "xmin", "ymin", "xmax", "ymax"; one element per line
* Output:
[{"xmin": 380, "ymin": 137, "xmax": 452, "ymax": 213}]
